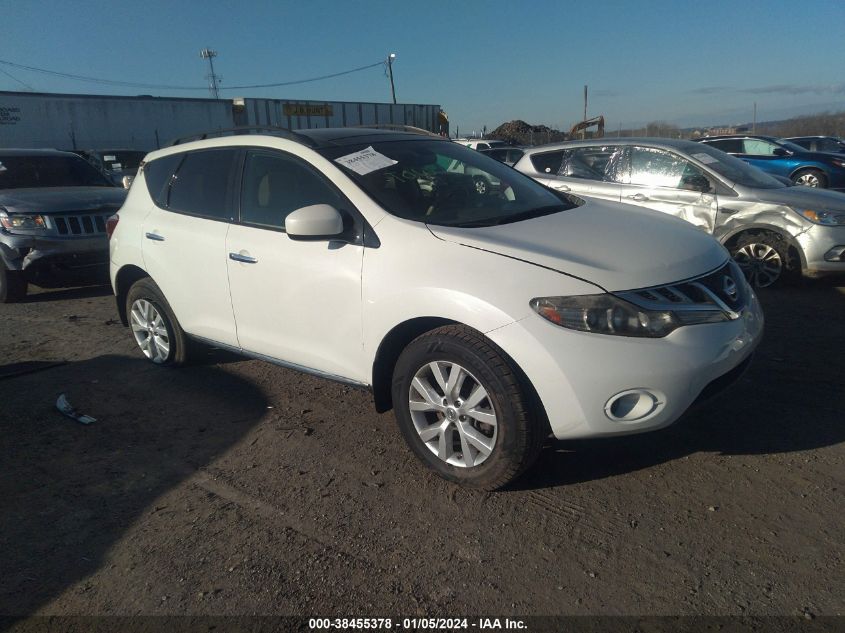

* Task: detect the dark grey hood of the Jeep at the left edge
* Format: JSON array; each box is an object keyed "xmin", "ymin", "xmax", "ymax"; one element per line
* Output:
[{"xmin": 0, "ymin": 187, "xmax": 126, "ymax": 214}]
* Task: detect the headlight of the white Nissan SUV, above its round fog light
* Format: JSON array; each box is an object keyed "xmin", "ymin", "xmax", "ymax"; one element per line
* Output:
[{"xmin": 531, "ymin": 294, "xmax": 730, "ymax": 338}]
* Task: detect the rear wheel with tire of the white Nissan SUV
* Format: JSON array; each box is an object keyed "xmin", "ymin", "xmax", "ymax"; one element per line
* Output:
[{"xmin": 126, "ymin": 277, "xmax": 188, "ymax": 365}]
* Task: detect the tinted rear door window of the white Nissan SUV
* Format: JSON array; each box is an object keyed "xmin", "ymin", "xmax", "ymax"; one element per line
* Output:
[{"xmin": 167, "ymin": 149, "xmax": 237, "ymax": 219}]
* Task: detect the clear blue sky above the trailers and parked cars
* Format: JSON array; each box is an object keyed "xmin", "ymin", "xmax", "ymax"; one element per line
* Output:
[{"xmin": 0, "ymin": 0, "xmax": 845, "ymax": 134}]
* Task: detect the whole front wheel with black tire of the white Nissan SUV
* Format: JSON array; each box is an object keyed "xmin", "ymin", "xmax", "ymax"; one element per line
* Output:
[{"xmin": 392, "ymin": 325, "xmax": 545, "ymax": 490}]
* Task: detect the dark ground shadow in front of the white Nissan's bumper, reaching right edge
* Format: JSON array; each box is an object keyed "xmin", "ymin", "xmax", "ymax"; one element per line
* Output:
[{"xmin": 511, "ymin": 278, "xmax": 845, "ymax": 490}]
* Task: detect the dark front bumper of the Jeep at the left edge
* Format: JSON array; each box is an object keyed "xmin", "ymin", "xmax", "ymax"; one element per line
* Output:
[{"xmin": 0, "ymin": 230, "xmax": 109, "ymax": 288}]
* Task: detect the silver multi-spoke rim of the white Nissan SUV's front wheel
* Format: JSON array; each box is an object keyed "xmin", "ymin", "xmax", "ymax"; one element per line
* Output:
[{"xmin": 408, "ymin": 361, "xmax": 498, "ymax": 468}]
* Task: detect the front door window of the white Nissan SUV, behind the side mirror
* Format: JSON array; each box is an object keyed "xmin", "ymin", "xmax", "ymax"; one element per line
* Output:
[{"xmin": 241, "ymin": 152, "xmax": 345, "ymax": 229}]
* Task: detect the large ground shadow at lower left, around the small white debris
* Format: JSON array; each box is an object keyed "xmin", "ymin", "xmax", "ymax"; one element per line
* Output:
[{"xmin": 0, "ymin": 356, "xmax": 267, "ymax": 616}]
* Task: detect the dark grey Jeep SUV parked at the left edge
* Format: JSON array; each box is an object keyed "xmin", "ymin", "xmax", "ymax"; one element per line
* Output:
[{"xmin": 0, "ymin": 149, "xmax": 126, "ymax": 303}]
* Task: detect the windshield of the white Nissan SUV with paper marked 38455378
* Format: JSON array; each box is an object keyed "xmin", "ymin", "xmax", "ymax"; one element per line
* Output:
[{"xmin": 321, "ymin": 139, "xmax": 575, "ymax": 227}]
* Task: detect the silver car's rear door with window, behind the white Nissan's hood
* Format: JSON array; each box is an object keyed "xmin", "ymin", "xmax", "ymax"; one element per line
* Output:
[{"xmin": 532, "ymin": 145, "xmax": 622, "ymax": 202}]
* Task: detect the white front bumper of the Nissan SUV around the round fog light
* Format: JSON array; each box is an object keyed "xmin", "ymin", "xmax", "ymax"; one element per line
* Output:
[{"xmin": 487, "ymin": 295, "xmax": 763, "ymax": 439}]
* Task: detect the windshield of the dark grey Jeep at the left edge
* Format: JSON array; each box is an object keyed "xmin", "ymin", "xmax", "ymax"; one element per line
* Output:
[{"xmin": 0, "ymin": 154, "xmax": 114, "ymax": 189}]
